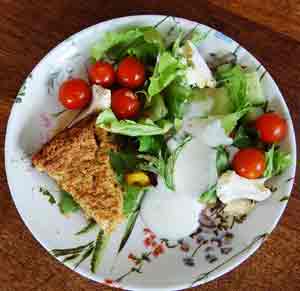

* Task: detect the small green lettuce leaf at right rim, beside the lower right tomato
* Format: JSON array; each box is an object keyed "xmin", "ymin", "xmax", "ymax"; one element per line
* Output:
[{"xmin": 264, "ymin": 144, "xmax": 292, "ymax": 178}]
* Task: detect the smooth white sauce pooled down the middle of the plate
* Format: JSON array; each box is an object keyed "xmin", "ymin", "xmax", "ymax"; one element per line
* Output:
[{"xmin": 141, "ymin": 114, "xmax": 231, "ymax": 240}]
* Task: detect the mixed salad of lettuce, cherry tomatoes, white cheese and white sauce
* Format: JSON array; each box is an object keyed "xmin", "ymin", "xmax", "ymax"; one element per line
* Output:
[{"xmin": 37, "ymin": 22, "xmax": 291, "ymax": 274}]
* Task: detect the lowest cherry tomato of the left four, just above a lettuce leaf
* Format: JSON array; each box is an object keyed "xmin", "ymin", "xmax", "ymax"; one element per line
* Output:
[{"xmin": 111, "ymin": 88, "xmax": 141, "ymax": 119}]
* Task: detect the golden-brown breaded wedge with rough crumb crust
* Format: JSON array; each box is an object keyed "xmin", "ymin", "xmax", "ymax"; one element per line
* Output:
[{"xmin": 32, "ymin": 116, "xmax": 123, "ymax": 233}]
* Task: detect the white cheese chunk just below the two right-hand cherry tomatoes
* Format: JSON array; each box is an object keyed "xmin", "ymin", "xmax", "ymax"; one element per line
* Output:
[{"xmin": 217, "ymin": 171, "xmax": 271, "ymax": 204}]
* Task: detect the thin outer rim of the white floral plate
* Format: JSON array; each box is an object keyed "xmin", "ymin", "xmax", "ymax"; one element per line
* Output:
[{"xmin": 4, "ymin": 14, "xmax": 297, "ymax": 291}]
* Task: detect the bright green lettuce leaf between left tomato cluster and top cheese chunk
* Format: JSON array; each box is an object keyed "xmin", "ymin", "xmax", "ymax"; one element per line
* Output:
[{"xmin": 148, "ymin": 51, "xmax": 185, "ymax": 96}]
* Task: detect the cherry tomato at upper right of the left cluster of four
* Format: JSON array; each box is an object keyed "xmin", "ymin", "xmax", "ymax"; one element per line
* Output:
[{"xmin": 117, "ymin": 57, "xmax": 145, "ymax": 89}]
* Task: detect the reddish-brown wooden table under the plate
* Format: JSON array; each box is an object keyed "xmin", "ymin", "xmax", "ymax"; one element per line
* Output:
[{"xmin": 0, "ymin": 0, "xmax": 300, "ymax": 291}]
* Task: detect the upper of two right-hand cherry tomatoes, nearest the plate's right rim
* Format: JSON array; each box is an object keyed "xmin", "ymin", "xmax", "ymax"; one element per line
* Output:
[{"xmin": 255, "ymin": 112, "xmax": 287, "ymax": 143}]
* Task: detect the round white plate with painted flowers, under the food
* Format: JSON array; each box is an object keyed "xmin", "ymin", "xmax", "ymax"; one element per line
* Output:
[{"xmin": 5, "ymin": 15, "xmax": 296, "ymax": 291}]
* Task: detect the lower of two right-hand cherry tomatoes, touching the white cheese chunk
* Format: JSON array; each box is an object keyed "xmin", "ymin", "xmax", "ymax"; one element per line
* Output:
[{"xmin": 232, "ymin": 148, "xmax": 266, "ymax": 179}]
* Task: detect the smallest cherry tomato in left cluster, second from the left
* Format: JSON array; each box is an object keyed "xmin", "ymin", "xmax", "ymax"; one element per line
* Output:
[{"xmin": 89, "ymin": 62, "xmax": 115, "ymax": 88}]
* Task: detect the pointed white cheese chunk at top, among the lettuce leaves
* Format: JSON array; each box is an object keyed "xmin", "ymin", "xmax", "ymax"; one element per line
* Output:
[{"xmin": 183, "ymin": 40, "xmax": 216, "ymax": 88}]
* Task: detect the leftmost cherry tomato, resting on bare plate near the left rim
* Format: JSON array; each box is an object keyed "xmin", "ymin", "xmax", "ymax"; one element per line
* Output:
[{"xmin": 58, "ymin": 79, "xmax": 92, "ymax": 109}]
